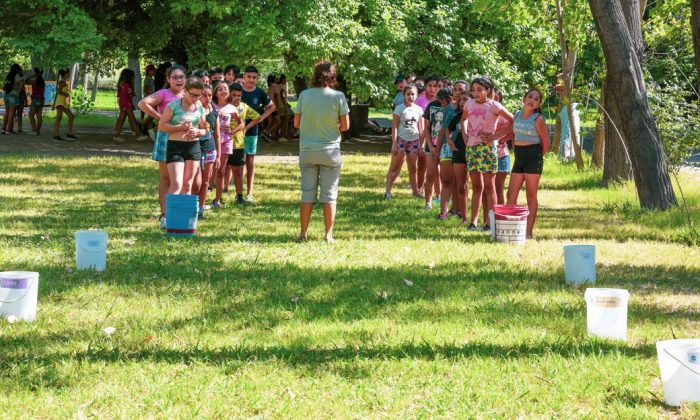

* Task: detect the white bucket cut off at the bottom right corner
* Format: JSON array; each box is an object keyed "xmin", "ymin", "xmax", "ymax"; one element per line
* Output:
[{"xmin": 656, "ymin": 339, "xmax": 700, "ymax": 406}]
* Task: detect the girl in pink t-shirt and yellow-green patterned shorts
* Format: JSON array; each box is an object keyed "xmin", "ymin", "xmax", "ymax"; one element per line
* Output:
[{"xmin": 462, "ymin": 77, "xmax": 513, "ymax": 231}]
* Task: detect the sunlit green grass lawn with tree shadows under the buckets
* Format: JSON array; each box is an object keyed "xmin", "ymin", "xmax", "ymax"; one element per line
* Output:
[{"xmin": 0, "ymin": 154, "xmax": 700, "ymax": 418}]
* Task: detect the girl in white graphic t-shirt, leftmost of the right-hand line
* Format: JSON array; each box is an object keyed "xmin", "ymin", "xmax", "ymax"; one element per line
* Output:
[{"xmin": 384, "ymin": 85, "xmax": 423, "ymax": 200}]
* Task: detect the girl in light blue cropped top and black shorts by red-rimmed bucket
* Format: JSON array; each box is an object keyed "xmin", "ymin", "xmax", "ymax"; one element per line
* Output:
[{"xmin": 508, "ymin": 89, "xmax": 549, "ymax": 239}]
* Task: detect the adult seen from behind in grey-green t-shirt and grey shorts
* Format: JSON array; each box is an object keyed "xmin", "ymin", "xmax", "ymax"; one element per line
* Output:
[{"xmin": 294, "ymin": 61, "xmax": 350, "ymax": 242}]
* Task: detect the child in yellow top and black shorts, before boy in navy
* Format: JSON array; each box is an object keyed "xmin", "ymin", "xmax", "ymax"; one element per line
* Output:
[{"xmin": 227, "ymin": 83, "xmax": 260, "ymax": 205}]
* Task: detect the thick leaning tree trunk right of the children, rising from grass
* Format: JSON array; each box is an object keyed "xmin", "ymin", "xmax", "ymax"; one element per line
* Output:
[{"xmin": 588, "ymin": 0, "xmax": 678, "ymax": 209}]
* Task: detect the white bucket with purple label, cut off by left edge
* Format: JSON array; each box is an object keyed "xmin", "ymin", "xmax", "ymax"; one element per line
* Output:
[{"xmin": 0, "ymin": 271, "xmax": 39, "ymax": 321}]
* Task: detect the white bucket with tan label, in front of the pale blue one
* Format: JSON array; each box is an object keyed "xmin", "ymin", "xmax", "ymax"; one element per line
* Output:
[{"xmin": 584, "ymin": 288, "xmax": 630, "ymax": 340}]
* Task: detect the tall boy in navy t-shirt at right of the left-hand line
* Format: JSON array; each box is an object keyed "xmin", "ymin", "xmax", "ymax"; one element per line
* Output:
[{"xmin": 242, "ymin": 66, "xmax": 275, "ymax": 204}]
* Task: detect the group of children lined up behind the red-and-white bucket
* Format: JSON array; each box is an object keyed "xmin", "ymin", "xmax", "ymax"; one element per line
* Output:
[{"xmin": 384, "ymin": 76, "xmax": 549, "ymax": 238}]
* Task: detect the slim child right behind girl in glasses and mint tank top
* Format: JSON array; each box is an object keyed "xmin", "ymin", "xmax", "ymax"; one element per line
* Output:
[{"xmin": 195, "ymin": 84, "xmax": 221, "ymax": 219}]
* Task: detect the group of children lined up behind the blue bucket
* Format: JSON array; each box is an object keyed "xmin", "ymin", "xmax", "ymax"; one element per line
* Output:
[{"xmin": 137, "ymin": 65, "xmax": 276, "ymax": 228}]
